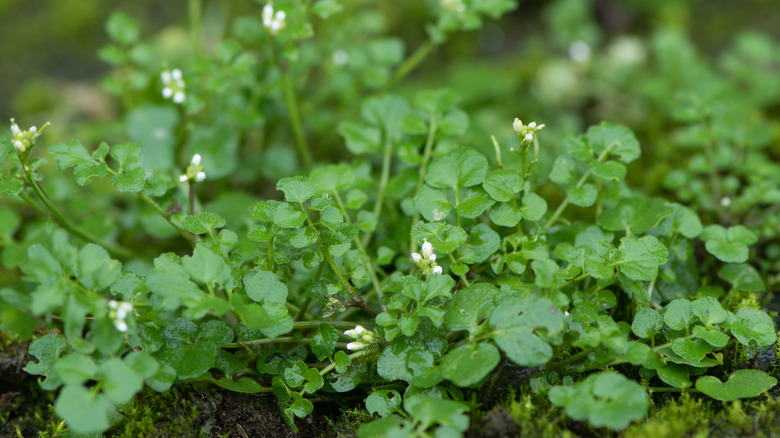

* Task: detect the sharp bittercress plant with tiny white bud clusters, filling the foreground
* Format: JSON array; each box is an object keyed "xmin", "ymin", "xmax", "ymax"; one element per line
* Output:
[{"xmin": 0, "ymin": 0, "xmax": 777, "ymax": 437}]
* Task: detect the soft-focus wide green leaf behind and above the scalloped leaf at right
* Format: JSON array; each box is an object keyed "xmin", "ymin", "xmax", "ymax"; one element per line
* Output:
[{"xmin": 598, "ymin": 198, "xmax": 674, "ymax": 234}]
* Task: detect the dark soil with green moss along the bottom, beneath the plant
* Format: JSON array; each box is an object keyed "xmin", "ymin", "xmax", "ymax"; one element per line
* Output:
[{"xmin": 0, "ymin": 334, "xmax": 780, "ymax": 438}]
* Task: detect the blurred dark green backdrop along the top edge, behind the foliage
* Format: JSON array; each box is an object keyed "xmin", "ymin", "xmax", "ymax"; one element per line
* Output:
[{"xmin": 0, "ymin": 0, "xmax": 780, "ymax": 127}]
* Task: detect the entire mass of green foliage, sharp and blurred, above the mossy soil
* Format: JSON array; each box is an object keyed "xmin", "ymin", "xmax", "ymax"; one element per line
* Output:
[{"xmin": 0, "ymin": 0, "xmax": 780, "ymax": 437}]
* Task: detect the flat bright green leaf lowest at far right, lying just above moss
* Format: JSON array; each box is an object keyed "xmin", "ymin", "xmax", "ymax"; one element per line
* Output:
[{"xmin": 696, "ymin": 370, "xmax": 777, "ymax": 402}]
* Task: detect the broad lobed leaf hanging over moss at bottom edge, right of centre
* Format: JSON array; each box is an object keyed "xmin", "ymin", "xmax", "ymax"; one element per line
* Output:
[{"xmin": 549, "ymin": 372, "xmax": 650, "ymax": 430}]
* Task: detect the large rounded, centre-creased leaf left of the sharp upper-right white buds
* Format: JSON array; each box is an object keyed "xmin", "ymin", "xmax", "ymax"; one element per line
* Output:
[{"xmin": 425, "ymin": 147, "xmax": 488, "ymax": 189}]
